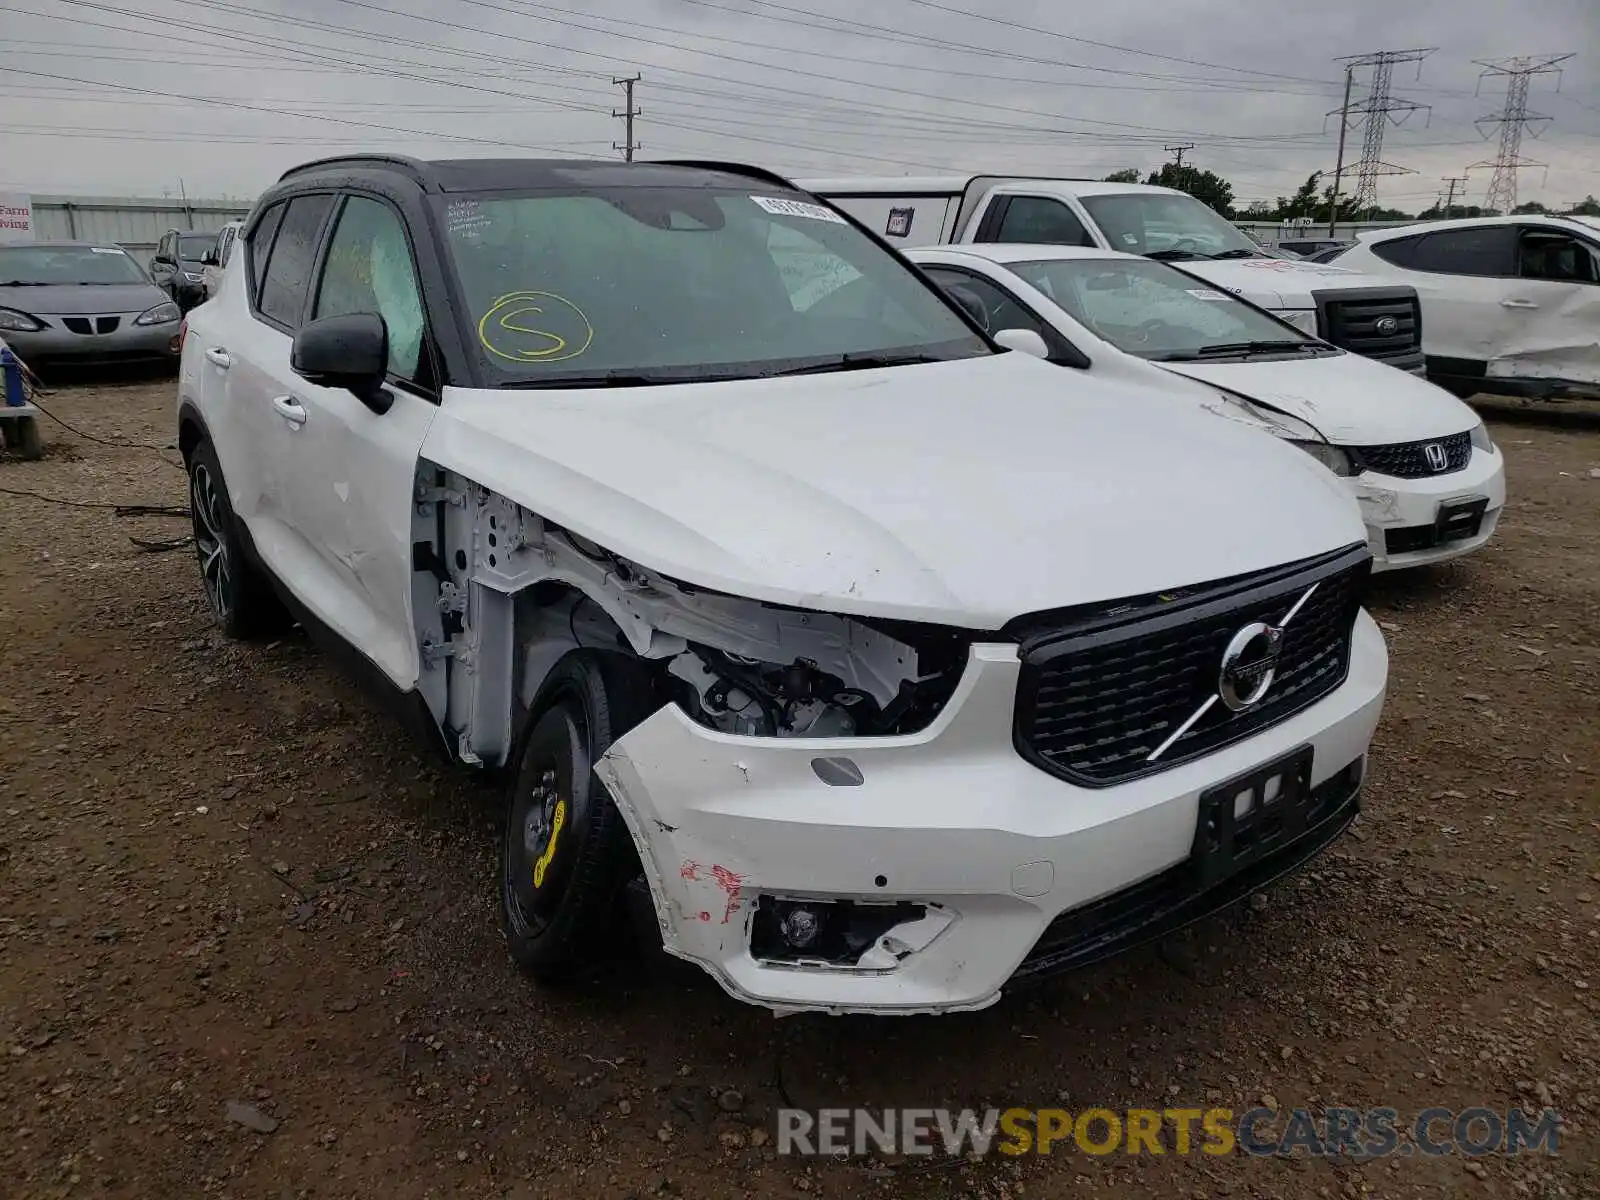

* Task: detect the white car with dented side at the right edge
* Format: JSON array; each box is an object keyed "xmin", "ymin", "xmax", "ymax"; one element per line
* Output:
[{"xmin": 1334, "ymin": 214, "xmax": 1600, "ymax": 400}]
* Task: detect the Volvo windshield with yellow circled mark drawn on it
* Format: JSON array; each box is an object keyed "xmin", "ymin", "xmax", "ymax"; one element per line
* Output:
[{"xmin": 438, "ymin": 187, "xmax": 992, "ymax": 386}]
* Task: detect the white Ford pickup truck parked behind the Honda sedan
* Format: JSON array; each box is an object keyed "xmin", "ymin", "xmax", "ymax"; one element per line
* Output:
[{"xmin": 812, "ymin": 174, "xmax": 1422, "ymax": 371}]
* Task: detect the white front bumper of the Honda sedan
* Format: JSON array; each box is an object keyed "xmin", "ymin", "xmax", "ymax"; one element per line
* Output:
[{"xmin": 1350, "ymin": 446, "xmax": 1506, "ymax": 573}]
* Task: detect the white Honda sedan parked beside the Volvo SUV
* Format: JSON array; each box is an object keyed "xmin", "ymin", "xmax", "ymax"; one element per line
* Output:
[{"xmin": 906, "ymin": 245, "xmax": 1506, "ymax": 571}]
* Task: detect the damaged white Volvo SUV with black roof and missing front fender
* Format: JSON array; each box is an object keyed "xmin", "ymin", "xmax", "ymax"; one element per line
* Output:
[{"xmin": 168, "ymin": 157, "xmax": 1387, "ymax": 1013}]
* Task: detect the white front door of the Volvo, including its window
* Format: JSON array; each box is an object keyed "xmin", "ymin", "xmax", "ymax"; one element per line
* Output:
[{"xmin": 280, "ymin": 194, "xmax": 438, "ymax": 688}]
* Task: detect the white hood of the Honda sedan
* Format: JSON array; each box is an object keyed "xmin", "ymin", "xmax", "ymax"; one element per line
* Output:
[{"xmin": 1160, "ymin": 354, "xmax": 1478, "ymax": 446}]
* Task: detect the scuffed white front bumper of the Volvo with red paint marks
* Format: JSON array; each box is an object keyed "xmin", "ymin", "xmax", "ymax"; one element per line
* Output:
[{"xmin": 598, "ymin": 611, "xmax": 1387, "ymax": 1013}]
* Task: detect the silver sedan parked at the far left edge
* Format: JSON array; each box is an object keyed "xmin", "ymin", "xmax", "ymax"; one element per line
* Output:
[{"xmin": 0, "ymin": 242, "xmax": 182, "ymax": 370}]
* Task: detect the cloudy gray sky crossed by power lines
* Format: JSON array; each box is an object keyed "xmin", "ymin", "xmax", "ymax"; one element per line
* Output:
[{"xmin": 0, "ymin": 0, "xmax": 1600, "ymax": 210}]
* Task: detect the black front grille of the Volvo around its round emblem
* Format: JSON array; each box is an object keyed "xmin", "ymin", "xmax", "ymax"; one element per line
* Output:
[{"xmin": 1014, "ymin": 546, "xmax": 1371, "ymax": 787}]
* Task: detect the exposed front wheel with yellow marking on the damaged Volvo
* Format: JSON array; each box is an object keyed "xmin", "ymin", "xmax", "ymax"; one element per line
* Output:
[{"xmin": 501, "ymin": 651, "xmax": 653, "ymax": 982}]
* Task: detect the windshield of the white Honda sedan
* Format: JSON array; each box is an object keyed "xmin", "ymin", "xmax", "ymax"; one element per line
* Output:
[{"xmin": 1008, "ymin": 258, "xmax": 1320, "ymax": 360}]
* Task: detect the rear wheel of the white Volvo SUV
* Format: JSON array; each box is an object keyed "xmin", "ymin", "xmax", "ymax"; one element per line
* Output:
[{"xmin": 189, "ymin": 438, "xmax": 293, "ymax": 638}]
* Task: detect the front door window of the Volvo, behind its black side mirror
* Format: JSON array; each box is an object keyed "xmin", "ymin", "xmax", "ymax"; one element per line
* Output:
[{"xmin": 312, "ymin": 195, "xmax": 422, "ymax": 381}]
